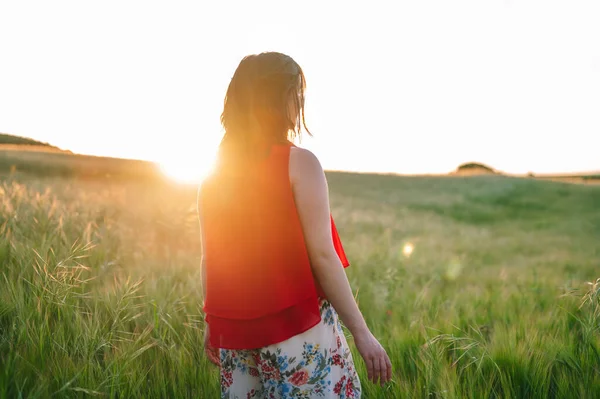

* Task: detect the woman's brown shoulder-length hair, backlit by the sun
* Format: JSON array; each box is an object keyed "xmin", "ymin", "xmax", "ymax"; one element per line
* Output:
[{"xmin": 220, "ymin": 52, "xmax": 311, "ymax": 166}]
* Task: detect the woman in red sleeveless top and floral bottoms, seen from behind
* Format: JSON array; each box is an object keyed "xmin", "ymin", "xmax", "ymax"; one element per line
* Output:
[{"xmin": 198, "ymin": 52, "xmax": 391, "ymax": 398}]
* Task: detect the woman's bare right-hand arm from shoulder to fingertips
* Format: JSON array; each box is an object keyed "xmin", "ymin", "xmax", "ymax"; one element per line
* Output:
[{"xmin": 290, "ymin": 147, "xmax": 392, "ymax": 384}]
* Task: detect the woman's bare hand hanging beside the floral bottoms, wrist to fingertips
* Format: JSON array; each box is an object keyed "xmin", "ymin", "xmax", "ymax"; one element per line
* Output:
[{"xmin": 354, "ymin": 330, "xmax": 392, "ymax": 386}]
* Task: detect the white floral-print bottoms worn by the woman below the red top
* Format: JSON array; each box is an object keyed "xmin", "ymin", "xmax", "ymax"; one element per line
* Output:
[{"xmin": 220, "ymin": 300, "xmax": 361, "ymax": 399}]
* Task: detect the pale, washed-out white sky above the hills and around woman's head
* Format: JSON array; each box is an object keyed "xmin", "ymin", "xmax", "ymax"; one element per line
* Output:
[{"xmin": 0, "ymin": 0, "xmax": 600, "ymax": 178}]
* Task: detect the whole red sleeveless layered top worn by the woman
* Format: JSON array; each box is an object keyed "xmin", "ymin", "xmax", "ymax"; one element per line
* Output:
[{"xmin": 198, "ymin": 143, "xmax": 349, "ymax": 349}]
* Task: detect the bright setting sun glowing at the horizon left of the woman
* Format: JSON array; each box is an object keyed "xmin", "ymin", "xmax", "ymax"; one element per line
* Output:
[{"xmin": 158, "ymin": 152, "xmax": 214, "ymax": 184}]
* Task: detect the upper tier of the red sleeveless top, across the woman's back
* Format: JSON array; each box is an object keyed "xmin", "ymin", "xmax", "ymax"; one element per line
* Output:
[{"xmin": 200, "ymin": 145, "xmax": 316, "ymax": 319}]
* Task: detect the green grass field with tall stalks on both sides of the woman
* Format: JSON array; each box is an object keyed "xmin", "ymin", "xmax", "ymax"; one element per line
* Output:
[{"xmin": 0, "ymin": 151, "xmax": 600, "ymax": 398}]
